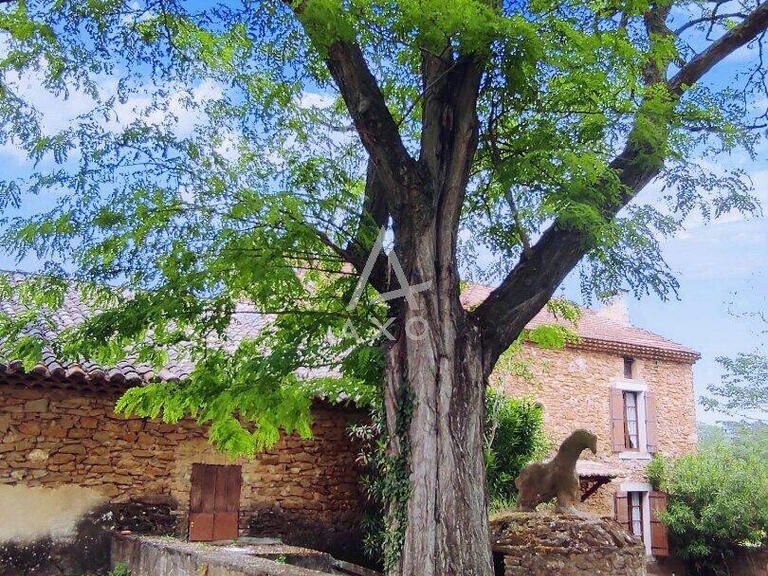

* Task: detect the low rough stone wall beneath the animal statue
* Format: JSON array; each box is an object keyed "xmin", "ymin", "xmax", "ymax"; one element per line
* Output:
[{"xmin": 491, "ymin": 512, "xmax": 646, "ymax": 576}]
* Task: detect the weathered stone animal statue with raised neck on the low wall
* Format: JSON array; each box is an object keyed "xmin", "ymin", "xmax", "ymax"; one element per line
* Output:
[{"xmin": 515, "ymin": 430, "xmax": 597, "ymax": 514}]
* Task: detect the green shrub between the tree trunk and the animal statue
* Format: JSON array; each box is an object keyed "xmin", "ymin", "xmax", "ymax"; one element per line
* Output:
[{"xmin": 485, "ymin": 388, "xmax": 549, "ymax": 511}]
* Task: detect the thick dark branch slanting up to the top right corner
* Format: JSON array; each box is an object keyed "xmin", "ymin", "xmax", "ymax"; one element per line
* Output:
[{"xmin": 471, "ymin": 3, "xmax": 768, "ymax": 374}]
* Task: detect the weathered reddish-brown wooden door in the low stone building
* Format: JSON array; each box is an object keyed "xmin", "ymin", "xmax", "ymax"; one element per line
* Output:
[{"xmin": 189, "ymin": 464, "xmax": 241, "ymax": 541}]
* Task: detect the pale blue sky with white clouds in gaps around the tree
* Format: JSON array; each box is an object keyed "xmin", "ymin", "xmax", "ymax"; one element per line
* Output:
[{"xmin": 0, "ymin": 33, "xmax": 768, "ymax": 422}]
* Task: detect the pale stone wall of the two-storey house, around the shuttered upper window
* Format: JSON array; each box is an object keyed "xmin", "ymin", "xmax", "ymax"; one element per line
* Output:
[{"xmin": 493, "ymin": 344, "xmax": 697, "ymax": 515}]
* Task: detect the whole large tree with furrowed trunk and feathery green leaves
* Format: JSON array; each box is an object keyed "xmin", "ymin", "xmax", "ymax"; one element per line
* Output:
[{"xmin": 0, "ymin": 0, "xmax": 768, "ymax": 576}]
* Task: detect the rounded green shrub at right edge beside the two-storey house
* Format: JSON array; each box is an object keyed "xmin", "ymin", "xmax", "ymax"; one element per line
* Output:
[{"xmin": 649, "ymin": 436, "xmax": 768, "ymax": 574}]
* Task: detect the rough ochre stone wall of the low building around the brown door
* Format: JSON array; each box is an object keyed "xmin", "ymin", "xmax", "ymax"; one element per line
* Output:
[{"xmin": 0, "ymin": 379, "xmax": 368, "ymax": 556}]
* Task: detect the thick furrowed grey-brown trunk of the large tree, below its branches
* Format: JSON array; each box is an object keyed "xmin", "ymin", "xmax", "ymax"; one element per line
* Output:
[{"xmin": 385, "ymin": 224, "xmax": 493, "ymax": 576}]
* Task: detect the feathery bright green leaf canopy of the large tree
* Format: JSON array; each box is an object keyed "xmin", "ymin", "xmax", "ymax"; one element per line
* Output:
[{"xmin": 0, "ymin": 0, "xmax": 766, "ymax": 451}]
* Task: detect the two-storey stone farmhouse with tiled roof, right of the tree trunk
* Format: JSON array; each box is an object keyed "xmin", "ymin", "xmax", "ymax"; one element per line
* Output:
[{"xmin": 462, "ymin": 286, "xmax": 700, "ymax": 557}]
